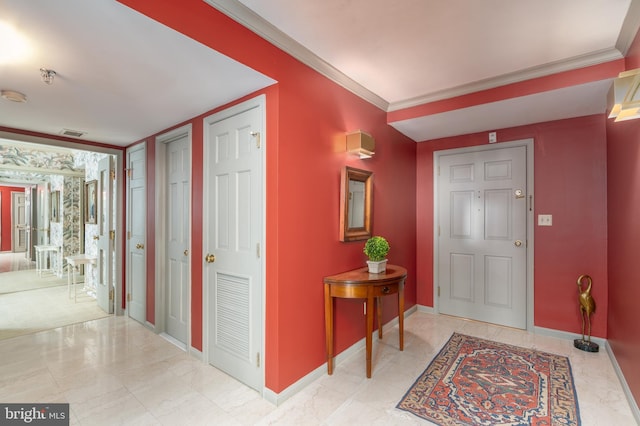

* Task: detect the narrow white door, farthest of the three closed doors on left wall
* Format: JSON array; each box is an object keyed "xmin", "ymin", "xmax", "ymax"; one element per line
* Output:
[{"xmin": 127, "ymin": 144, "xmax": 147, "ymax": 324}]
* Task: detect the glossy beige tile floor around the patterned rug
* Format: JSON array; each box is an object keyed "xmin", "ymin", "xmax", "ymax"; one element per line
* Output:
[{"xmin": 0, "ymin": 312, "xmax": 636, "ymax": 426}]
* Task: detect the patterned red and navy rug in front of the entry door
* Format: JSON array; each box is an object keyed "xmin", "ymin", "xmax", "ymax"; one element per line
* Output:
[{"xmin": 397, "ymin": 333, "xmax": 580, "ymax": 426}]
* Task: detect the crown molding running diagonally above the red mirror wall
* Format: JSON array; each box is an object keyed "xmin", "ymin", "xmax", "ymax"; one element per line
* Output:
[{"xmin": 204, "ymin": 0, "xmax": 389, "ymax": 111}]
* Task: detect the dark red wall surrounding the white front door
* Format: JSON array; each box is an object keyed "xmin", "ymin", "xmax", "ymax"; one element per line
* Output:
[{"xmin": 416, "ymin": 115, "xmax": 608, "ymax": 337}]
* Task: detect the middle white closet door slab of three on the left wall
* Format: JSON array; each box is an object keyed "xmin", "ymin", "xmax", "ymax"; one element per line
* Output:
[{"xmin": 164, "ymin": 134, "xmax": 191, "ymax": 343}]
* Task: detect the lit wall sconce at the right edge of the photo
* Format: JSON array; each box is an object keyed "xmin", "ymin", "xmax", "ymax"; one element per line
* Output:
[{"xmin": 607, "ymin": 69, "xmax": 640, "ymax": 121}]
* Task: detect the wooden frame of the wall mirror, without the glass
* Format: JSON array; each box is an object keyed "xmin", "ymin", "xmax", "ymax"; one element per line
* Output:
[{"xmin": 340, "ymin": 166, "xmax": 373, "ymax": 242}]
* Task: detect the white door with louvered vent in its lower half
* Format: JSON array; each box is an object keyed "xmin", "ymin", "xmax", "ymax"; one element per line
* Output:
[{"xmin": 203, "ymin": 96, "xmax": 265, "ymax": 391}]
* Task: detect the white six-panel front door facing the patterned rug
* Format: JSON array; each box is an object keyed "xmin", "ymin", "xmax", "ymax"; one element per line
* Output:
[{"xmin": 436, "ymin": 146, "xmax": 529, "ymax": 329}]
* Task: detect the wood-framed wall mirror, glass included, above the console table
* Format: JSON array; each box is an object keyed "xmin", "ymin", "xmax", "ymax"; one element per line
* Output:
[{"xmin": 340, "ymin": 166, "xmax": 373, "ymax": 241}]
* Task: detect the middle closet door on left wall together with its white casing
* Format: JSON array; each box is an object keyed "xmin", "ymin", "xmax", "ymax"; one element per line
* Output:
[{"xmin": 155, "ymin": 125, "xmax": 192, "ymax": 351}]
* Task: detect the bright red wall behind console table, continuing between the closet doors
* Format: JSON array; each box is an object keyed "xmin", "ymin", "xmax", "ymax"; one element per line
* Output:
[{"xmin": 121, "ymin": 0, "xmax": 416, "ymax": 392}]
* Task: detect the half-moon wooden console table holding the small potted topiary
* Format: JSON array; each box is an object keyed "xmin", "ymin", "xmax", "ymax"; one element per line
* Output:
[{"xmin": 324, "ymin": 265, "xmax": 407, "ymax": 378}]
